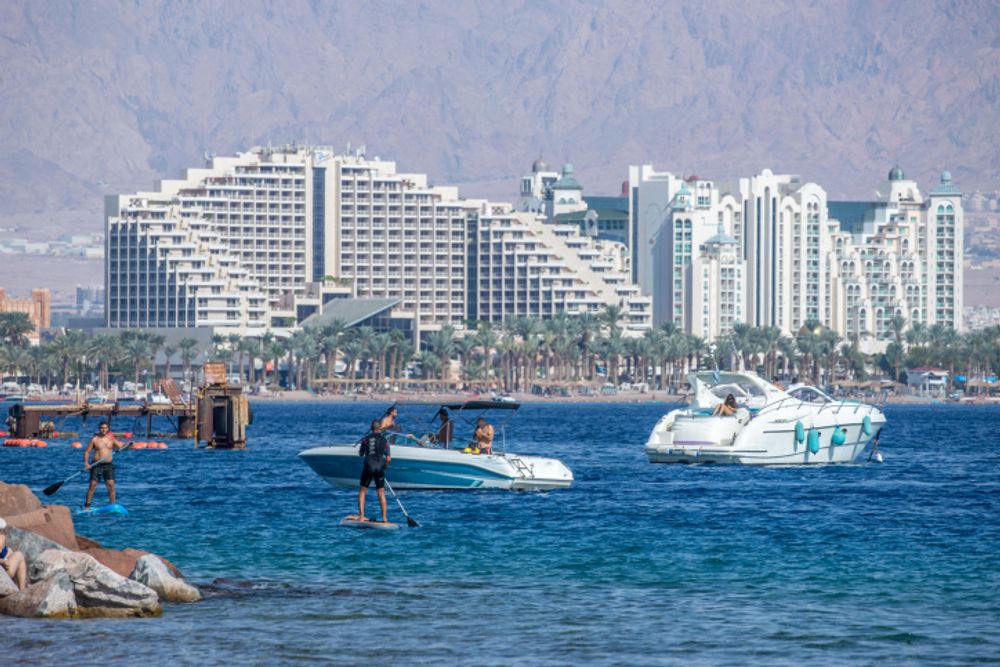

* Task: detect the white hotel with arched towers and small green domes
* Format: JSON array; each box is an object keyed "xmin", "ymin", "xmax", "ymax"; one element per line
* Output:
[{"xmin": 629, "ymin": 165, "xmax": 963, "ymax": 349}]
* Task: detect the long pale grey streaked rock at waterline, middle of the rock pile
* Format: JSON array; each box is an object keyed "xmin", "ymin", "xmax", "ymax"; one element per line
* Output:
[{"xmin": 28, "ymin": 549, "xmax": 162, "ymax": 616}]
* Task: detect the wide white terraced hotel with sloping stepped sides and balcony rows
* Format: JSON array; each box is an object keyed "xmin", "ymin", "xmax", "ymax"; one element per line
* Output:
[{"xmin": 105, "ymin": 146, "xmax": 651, "ymax": 336}]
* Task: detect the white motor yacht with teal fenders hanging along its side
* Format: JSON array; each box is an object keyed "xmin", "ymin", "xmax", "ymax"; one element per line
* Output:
[{"xmin": 646, "ymin": 371, "xmax": 885, "ymax": 465}]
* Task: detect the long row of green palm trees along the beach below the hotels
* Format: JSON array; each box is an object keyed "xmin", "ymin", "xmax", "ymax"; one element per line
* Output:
[{"xmin": 0, "ymin": 314, "xmax": 1000, "ymax": 391}]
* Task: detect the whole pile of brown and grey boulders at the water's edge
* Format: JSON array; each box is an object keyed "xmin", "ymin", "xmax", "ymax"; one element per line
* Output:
[{"xmin": 0, "ymin": 482, "xmax": 202, "ymax": 618}]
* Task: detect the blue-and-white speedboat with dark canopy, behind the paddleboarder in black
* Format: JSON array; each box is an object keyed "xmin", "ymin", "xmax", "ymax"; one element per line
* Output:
[{"xmin": 299, "ymin": 401, "xmax": 573, "ymax": 491}]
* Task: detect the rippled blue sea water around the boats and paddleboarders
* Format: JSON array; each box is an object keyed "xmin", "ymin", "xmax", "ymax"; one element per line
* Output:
[{"xmin": 0, "ymin": 402, "xmax": 1000, "ymax": 666}]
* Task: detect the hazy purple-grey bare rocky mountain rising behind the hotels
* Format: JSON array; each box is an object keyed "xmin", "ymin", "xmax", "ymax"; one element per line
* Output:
[{"xmin": 0, "ymin": 0, "xmax": 1000, "ymax": 231}]
